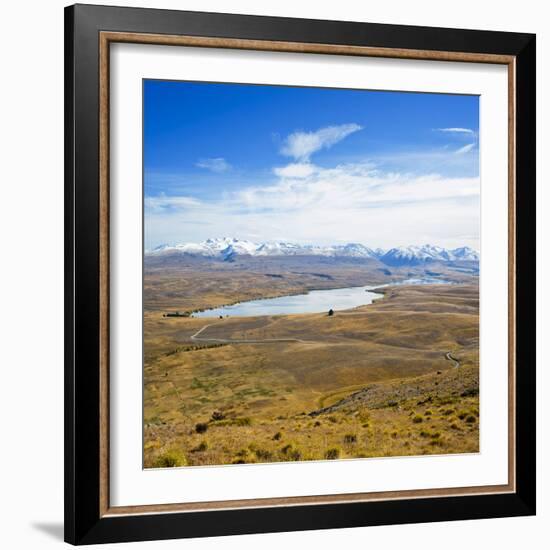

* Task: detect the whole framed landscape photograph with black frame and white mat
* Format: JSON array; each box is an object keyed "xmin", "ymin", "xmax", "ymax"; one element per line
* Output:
[{"xmin": 65, "ymin": 5, "xmax": 536, "ymax": 544}]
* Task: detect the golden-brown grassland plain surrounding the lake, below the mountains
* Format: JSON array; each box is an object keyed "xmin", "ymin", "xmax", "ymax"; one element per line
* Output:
[{"xmin": 144, "ymin": 264, "xmax": 479, "ymax": 467}]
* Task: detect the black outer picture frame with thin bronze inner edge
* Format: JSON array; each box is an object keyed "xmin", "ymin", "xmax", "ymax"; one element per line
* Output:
[{"xmin": 65, "ymin": 5, "xmax": 536, "ymax": 544}]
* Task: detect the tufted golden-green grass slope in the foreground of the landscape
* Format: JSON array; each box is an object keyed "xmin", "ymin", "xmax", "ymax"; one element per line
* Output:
[{"xmin": 145, "ymin": 367, "xmax": 479, "ymax": 467}]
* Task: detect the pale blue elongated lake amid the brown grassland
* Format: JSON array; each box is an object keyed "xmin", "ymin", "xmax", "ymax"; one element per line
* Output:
[{"xmin": 193, "ymin": 278, "xmax": 449, "ymax": 317}]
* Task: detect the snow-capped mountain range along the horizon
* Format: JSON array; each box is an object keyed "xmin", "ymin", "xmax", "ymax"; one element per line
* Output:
[{"xmin": 146, "ymin": 237, "xmax": 479, "ymax": 267}]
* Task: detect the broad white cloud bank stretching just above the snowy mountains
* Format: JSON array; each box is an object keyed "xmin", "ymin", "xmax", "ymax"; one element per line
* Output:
[{"xmin": 146, "ymin": 163, "xmax": 480, "ymax": 249}]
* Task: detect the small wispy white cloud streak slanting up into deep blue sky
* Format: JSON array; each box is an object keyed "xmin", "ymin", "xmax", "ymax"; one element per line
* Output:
[{"xmin": 281, "ymin": 123, "xmax": 362, "ymax": 163}]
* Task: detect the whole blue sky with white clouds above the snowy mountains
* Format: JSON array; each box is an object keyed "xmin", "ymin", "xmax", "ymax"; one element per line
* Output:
[{"xmin": 144, "ymin": 80, "xmax": 479, "ymax": 248}]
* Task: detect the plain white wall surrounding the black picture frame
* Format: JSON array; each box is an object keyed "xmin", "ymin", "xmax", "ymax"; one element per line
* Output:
[{"xmin": 0, "ymin": 0, "xmax": 550, "ymax": 550}]
